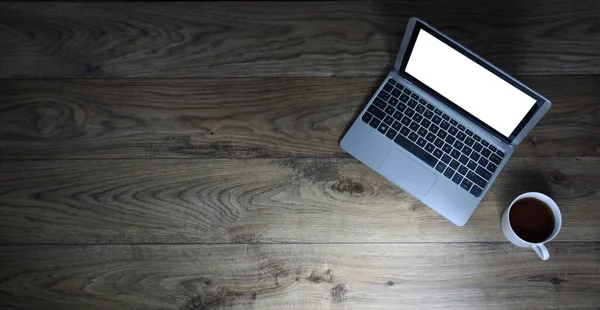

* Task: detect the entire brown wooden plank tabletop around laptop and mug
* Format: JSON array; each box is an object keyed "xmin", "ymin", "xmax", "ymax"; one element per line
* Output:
[{"xmin": 0, "ymin": 0, "xmax": 600, "ymax": 309}]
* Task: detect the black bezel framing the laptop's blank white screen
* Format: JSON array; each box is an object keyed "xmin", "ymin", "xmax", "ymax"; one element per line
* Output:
[{"xmin": 398, "ymin": 21, "xmax": 545, "ymax": 143}]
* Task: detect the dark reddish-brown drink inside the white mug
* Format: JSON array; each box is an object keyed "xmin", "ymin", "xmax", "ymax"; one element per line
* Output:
[{"xmin": 508, "ymin": 198, "xmax": 554, "ymax": 243}]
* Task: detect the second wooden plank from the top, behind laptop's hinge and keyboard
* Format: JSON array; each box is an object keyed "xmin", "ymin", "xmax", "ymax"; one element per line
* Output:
[{"xmin": 0, "ymin": 76, "xmax": 600, "ymax": 159}]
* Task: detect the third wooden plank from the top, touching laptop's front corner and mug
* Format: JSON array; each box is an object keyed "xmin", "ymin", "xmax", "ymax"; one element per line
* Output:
[{"xmin": 0, "ymin": 157, "xmax": 600, "ymax": 245}]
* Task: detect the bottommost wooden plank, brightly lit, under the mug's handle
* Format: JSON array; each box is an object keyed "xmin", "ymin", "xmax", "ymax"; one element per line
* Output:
[{"xmin": 0, "ymin": 243, "xmax": 600, "ymax": 309}]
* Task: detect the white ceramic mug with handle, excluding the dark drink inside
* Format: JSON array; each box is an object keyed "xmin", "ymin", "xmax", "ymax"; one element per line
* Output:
[{"xmin": 502, "ymin": 192, "xmax": 562, "ymax": 260}]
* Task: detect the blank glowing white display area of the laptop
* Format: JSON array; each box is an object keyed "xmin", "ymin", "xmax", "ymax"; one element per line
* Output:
[{"xmin": 405, "ymin": 29, "xmax": 536, "ymax": 137}]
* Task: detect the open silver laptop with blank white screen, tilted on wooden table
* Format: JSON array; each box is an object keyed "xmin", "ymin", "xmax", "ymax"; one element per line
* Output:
[{"xmin": 340, "ymin": 17, "xmax": 551, "ymax": 226}]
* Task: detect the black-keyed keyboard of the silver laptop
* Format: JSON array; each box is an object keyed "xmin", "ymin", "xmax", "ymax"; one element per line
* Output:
[{"xmin": 362, "ymin": 79, "xmax": 504, "ymax": 197}]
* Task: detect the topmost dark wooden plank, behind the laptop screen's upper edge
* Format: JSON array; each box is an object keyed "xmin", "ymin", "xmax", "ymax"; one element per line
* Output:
[{"xmin": 0, "ymin": 0, "xmax": 600, "ymax": 78}]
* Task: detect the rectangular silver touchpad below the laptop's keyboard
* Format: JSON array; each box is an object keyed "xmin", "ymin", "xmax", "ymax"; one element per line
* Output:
[{"xmin": 381, "ymin": 149, "xmax": 437, "ymax": 196}]
